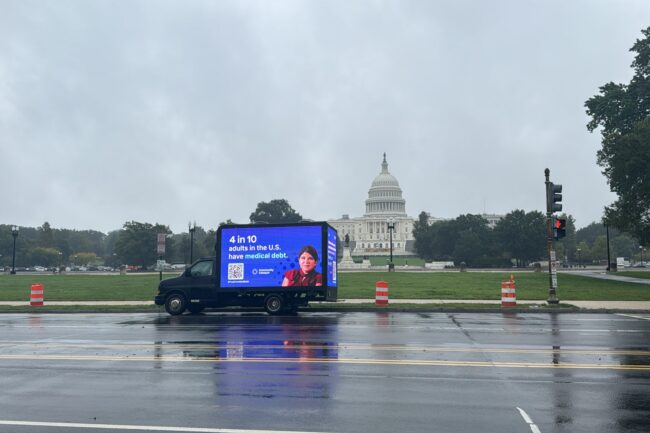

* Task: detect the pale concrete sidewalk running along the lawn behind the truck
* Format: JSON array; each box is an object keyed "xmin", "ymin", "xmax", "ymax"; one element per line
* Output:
[{"xmin": 0, "ymin": 299, "xmax": 650, "ymax": 312}]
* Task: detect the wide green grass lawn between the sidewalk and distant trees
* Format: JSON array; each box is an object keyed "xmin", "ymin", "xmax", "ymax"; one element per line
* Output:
[{"xmin": 0, "ymin": 272, "xmax": 650, "ymax": 301}]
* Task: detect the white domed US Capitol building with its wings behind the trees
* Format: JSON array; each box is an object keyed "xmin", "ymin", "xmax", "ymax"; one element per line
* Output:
[{"xmin": 327, "ymin": 153, "xmax": 503, "ymax": 256}]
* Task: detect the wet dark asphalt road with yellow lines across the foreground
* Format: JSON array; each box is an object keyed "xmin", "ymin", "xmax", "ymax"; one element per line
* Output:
[{"xmin": 0, "ymin": 313, "xmax": 650, "ymax": 433}]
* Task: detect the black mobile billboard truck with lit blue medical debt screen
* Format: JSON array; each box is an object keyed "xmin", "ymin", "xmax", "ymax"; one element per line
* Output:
[{"xmin": 155, "ymin": 222, "xmax": 338, "ymax": 315}]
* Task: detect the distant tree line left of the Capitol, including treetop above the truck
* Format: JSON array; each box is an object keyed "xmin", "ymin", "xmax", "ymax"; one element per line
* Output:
[{"xmin": 0, "ymin": 199, "xmax": 302, "ymax": 268}]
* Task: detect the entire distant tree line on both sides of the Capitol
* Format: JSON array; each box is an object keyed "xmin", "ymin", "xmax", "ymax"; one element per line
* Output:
[{"xmin": 0, "ymin": 199, "xmax": 640, "ymax": 268}]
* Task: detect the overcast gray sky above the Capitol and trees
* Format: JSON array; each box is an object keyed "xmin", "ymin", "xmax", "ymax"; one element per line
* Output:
[{"xmin": 0, "ymin": 0, "xmax": 650, "ymax": 233}]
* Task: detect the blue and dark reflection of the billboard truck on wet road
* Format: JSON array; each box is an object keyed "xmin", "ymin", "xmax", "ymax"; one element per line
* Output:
[{"xmin": 157, "ymin": 315, "xmax": 339, "ymax": 404}]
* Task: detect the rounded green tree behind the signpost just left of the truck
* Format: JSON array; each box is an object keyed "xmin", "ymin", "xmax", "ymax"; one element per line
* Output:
[{"xmin": 115, "ymin": 221, "xmax": 171, "ymax": 268}]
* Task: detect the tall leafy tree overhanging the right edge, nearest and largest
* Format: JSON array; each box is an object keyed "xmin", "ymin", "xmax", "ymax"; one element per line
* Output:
[{"xmin": 585, "ymin": 27, "xmax": 650, "ymax": 245}]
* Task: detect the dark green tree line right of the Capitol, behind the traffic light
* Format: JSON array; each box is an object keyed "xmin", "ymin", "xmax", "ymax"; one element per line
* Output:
[{"xmin": 413, "ymin": 210, "xmax": 640, "ymax": 268}]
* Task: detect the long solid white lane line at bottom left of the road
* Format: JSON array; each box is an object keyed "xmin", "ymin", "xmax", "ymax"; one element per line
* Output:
[{"xmin": 0, "ymin": 420, "xmax": 330, "ymax": 433}]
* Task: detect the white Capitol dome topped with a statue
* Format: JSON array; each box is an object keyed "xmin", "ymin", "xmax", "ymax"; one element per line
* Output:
[{"xmin": 365, "ymin": 153, "xmax": 406, "ymax": 217}]
